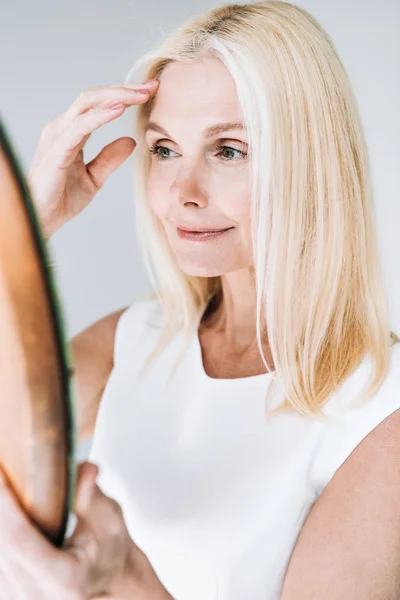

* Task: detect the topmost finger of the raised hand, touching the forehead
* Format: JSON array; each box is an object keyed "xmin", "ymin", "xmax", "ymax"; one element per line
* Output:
[{"xmin": 64, "ymin": 83, "xmax": 158, "ymax": 121}]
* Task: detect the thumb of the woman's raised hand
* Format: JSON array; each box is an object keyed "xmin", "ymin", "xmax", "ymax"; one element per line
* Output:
[{"xmin": 86, "ymin": 137, "xmax": 136, "ymax": 189}]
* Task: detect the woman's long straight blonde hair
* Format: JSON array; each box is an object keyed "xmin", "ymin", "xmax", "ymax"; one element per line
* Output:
[{"xmin": 126, "ymin": 1, "xmax": 400, "ymax": 418}]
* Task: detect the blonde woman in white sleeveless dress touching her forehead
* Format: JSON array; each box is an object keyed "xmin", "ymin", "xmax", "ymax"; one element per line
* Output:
[{"xmin": 4, "ymin": 1, "xmax": 400, "ymax": 600}]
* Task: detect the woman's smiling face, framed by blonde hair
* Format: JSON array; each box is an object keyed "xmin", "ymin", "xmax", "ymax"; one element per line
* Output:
[{"xmin": 146, "ymin": 58, "xmax": 252, "ymax": 277}]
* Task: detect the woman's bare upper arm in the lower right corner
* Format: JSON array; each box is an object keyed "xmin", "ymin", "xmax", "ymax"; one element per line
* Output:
[{"xmin": 281, "ymin": 409, "xmax": 400, "ymax": 600}]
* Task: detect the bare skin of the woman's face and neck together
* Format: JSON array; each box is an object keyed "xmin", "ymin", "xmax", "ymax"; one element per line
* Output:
[{"xmin": 146, "ymin": 58, "xmax": 273, "ymax": 378}]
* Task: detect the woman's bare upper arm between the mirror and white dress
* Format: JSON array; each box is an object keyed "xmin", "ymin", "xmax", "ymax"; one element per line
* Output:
[{"xmin": 69, "ymin": 306, "xmax": 128, "ymax": 443}]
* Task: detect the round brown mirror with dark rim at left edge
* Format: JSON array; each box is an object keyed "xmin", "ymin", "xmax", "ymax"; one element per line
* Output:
[{"xmin": 0, "ymin": 119, "xmax": 77, "ymax": 546}]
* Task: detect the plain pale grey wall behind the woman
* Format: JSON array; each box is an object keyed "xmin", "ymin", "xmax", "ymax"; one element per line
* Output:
[{"xmin": 0, "ymin": 0, "xmax": 400, "ymax": 458}]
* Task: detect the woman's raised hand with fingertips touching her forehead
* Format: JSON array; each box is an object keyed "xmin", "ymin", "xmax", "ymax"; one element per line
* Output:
[{"xmin": 27, "ymin": 80, "xmax": 159, "ymax": 239}]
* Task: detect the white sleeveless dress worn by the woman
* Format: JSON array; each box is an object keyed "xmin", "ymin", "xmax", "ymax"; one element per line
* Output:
[{"xmin": 89, "ymin": 300, "xmax": 400, "ymax": 600}]
